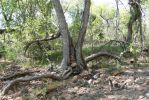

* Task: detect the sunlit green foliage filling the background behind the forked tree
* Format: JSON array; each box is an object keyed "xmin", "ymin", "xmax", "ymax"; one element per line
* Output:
[{"xmin": 0, "ymin": 0, "xmax": 149, "ymax": 69}]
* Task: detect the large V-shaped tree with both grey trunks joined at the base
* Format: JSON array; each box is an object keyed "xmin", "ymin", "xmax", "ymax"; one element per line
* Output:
[{"xmin": 51, "ymin": 0, "xmax": 91, "ymax": 71}]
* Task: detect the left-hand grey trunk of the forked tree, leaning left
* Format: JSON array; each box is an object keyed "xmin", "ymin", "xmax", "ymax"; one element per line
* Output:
[{"xmin": 51, "ymin": 0, "xmax": 72, "ymax": 69}]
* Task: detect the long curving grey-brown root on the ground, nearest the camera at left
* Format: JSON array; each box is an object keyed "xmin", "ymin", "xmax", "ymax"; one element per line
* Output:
[{"xmin": 1, "ymin": 73, "xmax": 62, "ymax": 95}]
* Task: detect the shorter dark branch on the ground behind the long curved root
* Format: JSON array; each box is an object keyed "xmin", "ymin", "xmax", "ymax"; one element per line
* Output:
[{"xmin": 0, "ymin": 71, "xmax": 38, "ymax": 81}]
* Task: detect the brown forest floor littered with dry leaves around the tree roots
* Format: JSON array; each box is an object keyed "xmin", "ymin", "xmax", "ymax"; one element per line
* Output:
[{"xmin": 0, "ymin": 56, "xmax": 149, "ymax": 100}]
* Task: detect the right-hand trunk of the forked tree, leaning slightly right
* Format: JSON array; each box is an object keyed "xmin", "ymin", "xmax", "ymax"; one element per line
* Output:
[{"xmin": 75, "ymin": 0, "xmax": 91, "ymax": 69}]
